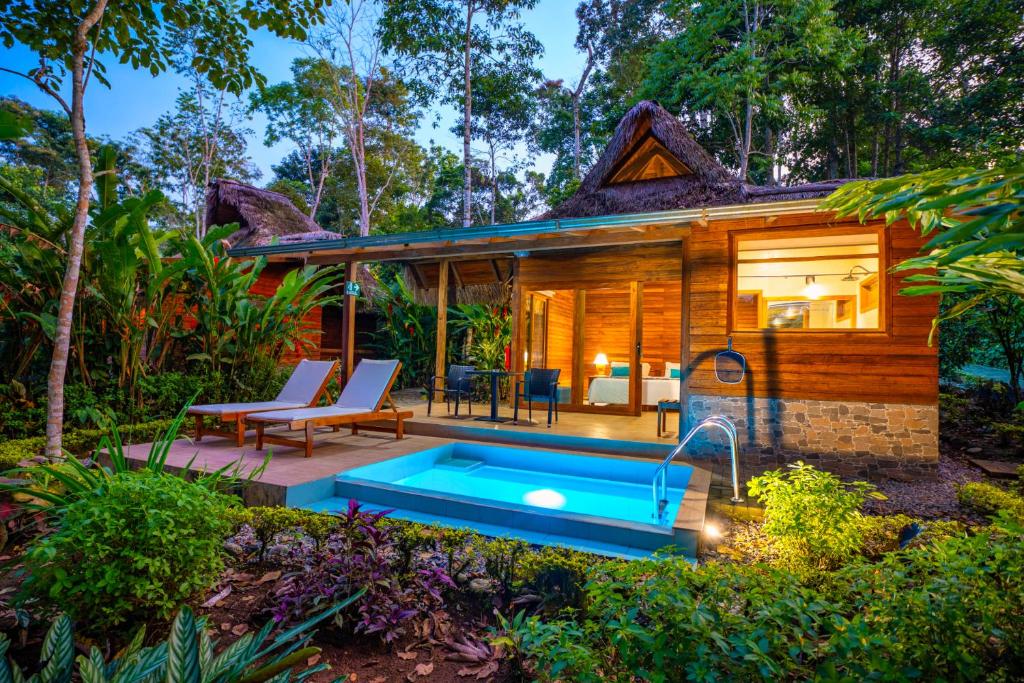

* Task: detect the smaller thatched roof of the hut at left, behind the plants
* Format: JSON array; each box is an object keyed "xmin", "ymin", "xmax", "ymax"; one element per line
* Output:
[{"xmin": 206, "ymin": 178, "xmax": 339, "ymax": 247}]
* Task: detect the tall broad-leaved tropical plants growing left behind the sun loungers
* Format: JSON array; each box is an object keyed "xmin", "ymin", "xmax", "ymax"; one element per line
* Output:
[{"xmin": 0, "ymin": 147, "xmax": 340, "ymax": 436}]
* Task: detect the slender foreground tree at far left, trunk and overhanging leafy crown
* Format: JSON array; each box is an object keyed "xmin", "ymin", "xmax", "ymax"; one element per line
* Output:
[{"xmin": 0, "ymin": 0, "xmax": 322, "ymax": 457}]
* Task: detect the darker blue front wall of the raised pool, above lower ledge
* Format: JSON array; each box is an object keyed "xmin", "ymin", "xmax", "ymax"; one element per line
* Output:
[{"xmin": 331, "ymin": 477, "xmax": 697, "ymax": 557}]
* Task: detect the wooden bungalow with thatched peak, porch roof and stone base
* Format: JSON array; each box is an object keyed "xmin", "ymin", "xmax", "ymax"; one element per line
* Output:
[{"xmin": 233, "ymin": 102, "xmax": 938, "ymax": 477}]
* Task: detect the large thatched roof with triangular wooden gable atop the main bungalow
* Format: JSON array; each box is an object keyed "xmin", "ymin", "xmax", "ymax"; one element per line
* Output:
[{"xmin": 541, "ymin": 100, "xmax": 843, "ymax": 218}]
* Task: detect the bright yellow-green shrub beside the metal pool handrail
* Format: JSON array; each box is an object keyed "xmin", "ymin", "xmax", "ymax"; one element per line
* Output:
[{"xmin": 748, "ymin": 462, "xmax": 874, "ymax": 569}]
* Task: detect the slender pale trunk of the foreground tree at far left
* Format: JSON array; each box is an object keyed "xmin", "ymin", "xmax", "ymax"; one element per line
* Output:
[{"xmin": 46, "ymin": 0, "xmax": 108, "ymax": 458}]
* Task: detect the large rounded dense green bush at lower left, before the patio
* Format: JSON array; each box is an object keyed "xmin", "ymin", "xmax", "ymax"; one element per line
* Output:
[{"xmin": 26, "ymin": 470, "xmax": 230, "ymax": 629}]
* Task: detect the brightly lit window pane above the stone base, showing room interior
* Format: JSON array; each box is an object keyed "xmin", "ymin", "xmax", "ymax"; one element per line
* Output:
[{"xmin": 732, "ymin": 230, "xmax": 884, "ymax": 330}]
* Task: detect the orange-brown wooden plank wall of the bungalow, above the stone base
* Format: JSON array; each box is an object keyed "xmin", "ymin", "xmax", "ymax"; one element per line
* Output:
[{"xmin": 516, "ymin": 214, "xmax": 938, "ymax": 404}]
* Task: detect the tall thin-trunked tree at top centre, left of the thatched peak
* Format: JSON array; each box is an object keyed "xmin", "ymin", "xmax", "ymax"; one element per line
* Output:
[{"xmin": 380, "ymin": 0, "xmax": 543, "ymax": 227}]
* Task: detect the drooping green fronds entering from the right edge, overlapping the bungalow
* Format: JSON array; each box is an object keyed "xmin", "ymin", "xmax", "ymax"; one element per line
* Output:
[{"xmin": 822, "ymin": 165, "xmax": 1024, "ymax": 402}]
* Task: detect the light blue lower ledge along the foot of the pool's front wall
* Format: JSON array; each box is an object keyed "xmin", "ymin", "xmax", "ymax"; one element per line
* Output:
[{"xmin": 303, "ymin": 497, "xmax": 675, "ymax": 560}]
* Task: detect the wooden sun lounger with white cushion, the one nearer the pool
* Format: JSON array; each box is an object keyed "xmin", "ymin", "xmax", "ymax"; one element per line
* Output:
[{"xmin": 246, "ymin": 360, "xmax": 413, "ymax": 458}]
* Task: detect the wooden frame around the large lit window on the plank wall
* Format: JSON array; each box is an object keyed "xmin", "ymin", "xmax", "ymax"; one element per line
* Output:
[{"xmin": 726, "ymin": 224, "xmax": 892, "ymax": 339}]
